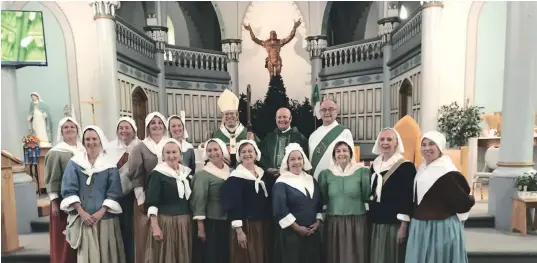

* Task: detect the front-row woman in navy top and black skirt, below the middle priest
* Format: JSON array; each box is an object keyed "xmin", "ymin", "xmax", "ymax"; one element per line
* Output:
[{"xmin": 272, "ymin": 143, "xmax": 323, "ymax": 263}]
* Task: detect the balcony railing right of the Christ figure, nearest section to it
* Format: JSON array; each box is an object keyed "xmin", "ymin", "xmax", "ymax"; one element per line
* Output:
[{"xmin": 322, "ymin": 37, "xmax": 383, "ymax": 68}]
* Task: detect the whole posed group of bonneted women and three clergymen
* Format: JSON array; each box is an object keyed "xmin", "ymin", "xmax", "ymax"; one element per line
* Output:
[{"xmin": 45, "ymin": 90, "xmax": 475, "ymax": 263}]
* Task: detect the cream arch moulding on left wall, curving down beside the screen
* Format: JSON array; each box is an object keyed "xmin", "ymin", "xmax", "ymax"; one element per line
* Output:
[{"xmin": 9, "ymin": 1, "xmax": 82, "ymax": 120}]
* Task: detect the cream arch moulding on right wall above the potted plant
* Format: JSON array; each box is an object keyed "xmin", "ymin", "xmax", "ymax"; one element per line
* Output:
[{"xmin": 464, "ymin": 1, "xmax": 485, "ymax": 104}]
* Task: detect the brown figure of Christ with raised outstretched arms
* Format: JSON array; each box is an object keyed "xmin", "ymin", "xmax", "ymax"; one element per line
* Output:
[{"xmin": 244, "ymin": 19, "xmax": 302, "ymax": 77}]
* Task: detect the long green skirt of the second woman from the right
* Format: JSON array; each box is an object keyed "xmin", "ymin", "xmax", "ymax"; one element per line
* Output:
[{"xmin": 370, "ymin": 224, "xmax": 406, "ymax": 263}]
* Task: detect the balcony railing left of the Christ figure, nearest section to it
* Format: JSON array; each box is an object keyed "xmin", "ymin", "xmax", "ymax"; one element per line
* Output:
[{"xmin": 164, "ymin": 45, "xmax": 227, "ymax": 72}]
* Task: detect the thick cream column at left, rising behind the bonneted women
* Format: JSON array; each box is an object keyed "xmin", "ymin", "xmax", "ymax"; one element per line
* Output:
[{"xmin": 89, "ymin": 1, "xmax": 121, "ymax": 138}]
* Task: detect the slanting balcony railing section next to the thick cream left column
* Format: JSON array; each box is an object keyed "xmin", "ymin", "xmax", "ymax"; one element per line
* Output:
[{"xmin": 116, "ymin": 16, "xmax": 156, "ymax": 59}]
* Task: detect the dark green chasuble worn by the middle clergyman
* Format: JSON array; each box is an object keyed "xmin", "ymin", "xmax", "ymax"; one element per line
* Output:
[{"xmin": 259, "ymin": 127, "xmax": 308, "ymax": 169}]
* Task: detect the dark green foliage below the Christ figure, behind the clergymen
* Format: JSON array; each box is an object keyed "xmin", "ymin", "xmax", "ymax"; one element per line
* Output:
[{"xmin": 239, "ymin": 76, "xmax": 320, "ymax": 139}]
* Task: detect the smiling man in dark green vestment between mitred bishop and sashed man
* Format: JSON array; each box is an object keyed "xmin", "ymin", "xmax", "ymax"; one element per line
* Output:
[{"xmin": 260, "ymin": 108, "xmax": 308, "ymax": 175}]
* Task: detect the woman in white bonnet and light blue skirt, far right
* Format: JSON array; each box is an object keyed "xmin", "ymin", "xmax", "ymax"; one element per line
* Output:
[{"xmin": 405, "ymin": 131, "xmax": 475, "ymax": 263}]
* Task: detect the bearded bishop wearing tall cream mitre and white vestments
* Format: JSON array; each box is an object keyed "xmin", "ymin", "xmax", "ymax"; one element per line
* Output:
[{"xmin": 211, "ymin": 89, "xmax": 259, "ymax": 167}]
